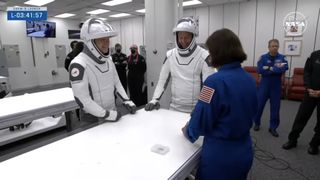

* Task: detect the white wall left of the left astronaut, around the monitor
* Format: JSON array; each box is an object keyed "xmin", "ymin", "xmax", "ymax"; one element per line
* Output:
[{"xmin": 0, "ymin": 12, "xmax": 79, "ymax": 90}]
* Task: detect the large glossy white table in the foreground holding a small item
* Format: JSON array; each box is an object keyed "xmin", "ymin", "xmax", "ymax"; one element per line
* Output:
[{"xmin": 0, "ymin": 109, "xmax": 201, "ymax": 180}]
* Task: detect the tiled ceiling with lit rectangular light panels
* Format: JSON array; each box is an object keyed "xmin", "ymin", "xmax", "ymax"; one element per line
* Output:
[{"xmin": 0, "ymin": 0, "xmax": 248, "ymax": 21}]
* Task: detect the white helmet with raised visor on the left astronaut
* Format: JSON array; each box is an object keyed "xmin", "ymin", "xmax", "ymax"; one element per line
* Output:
[{"xmin": 80, "ymin": 18, "xmax": 118, "ymax": 61}]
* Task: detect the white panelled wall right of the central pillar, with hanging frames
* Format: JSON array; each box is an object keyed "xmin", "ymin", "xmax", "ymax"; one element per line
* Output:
[{"xmin": 184, "ymin": 0, "xmax": 320, "ymax": 76}]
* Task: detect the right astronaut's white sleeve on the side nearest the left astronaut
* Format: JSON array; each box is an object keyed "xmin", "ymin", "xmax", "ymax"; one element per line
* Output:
[{"xmin": 152, "ymin": 58, "xmax": 171, "ymax": 100}]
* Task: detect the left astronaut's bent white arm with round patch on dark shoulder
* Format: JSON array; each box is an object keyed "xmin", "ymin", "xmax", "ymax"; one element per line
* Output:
[{"xmin": 69, "ymin": 63, "xmax": 106, "ymax": 117}]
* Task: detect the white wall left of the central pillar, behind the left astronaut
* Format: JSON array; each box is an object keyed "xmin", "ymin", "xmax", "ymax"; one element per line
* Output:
[{"xmin": 0, "ymin": 12, "xmax": 144, "ymax": 90}]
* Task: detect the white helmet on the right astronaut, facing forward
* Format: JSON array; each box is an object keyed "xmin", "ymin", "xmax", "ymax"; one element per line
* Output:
[{"xmin": 173, "ymin": 17, "xmax": 199, "ymax": 54}]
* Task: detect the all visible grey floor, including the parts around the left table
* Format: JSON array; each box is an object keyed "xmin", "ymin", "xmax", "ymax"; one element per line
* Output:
[{"xmin": 0, "ymin": 85, "xmax": 320, "ymax": 180}]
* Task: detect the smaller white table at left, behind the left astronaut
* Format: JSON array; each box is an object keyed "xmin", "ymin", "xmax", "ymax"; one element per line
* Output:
[{"xmin": 0, "ymin": 88, "xmax": 79, "ymax": 129}]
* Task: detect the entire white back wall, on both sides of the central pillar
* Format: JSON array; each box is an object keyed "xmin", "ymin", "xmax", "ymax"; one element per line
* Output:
[{"xmin": 0, "ymin": 0, "xmax": 320, "ymax": 89}]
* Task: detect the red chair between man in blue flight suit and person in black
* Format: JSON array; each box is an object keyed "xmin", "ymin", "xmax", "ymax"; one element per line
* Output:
[{"xmin": 287, "ymin": 68, "xmax": 305, "ymax": 101}]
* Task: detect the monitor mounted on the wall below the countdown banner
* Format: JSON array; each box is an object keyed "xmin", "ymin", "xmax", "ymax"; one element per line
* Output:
[{"xmin": 26, "ymin": 21, "xmax": 56, "ymax": 38}]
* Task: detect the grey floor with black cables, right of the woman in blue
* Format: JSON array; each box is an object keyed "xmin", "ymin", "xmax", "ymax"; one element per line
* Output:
[{"xmin": 248, "ymin": 100, "xmax": 320, "ymax": 180}]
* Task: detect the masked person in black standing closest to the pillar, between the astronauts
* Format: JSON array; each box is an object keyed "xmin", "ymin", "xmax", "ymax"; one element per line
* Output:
[{"xmin": 128, "ymin": 44, "xmax": 147, "ymax": 106}]
